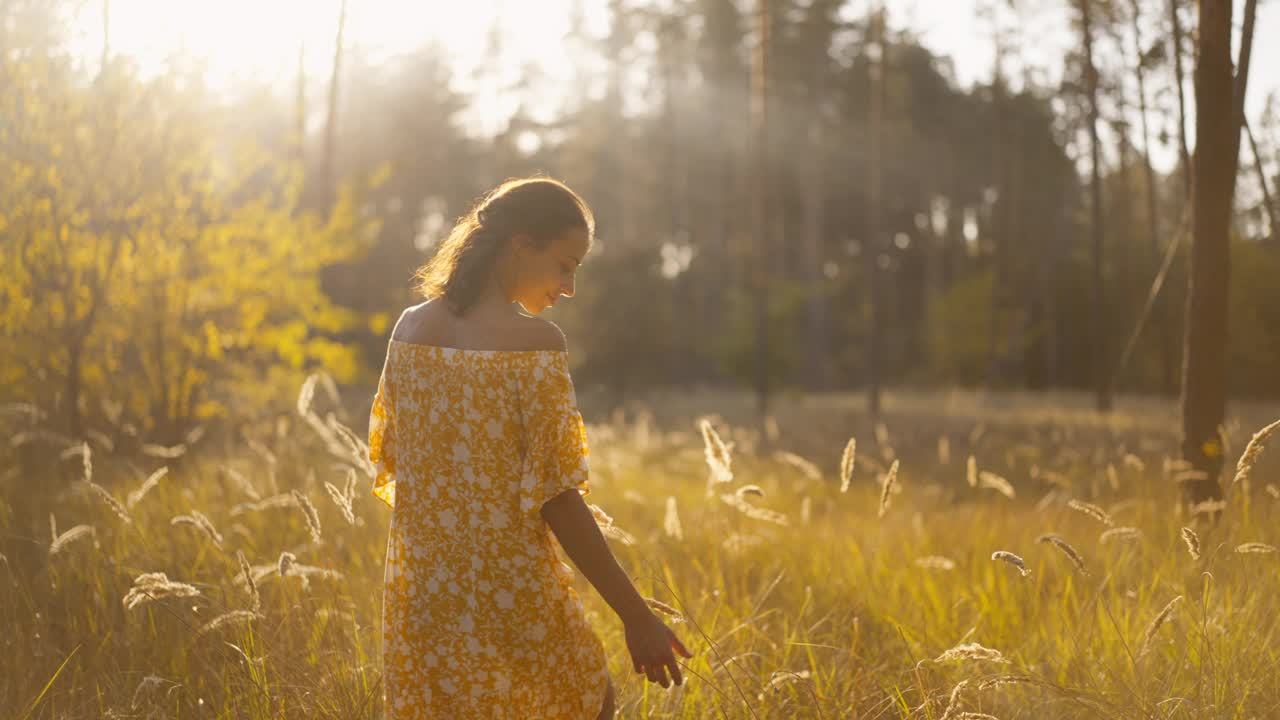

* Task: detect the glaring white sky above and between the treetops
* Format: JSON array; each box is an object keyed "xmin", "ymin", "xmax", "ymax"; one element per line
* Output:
[{"xmin": 67, "ymin": 0, "xmax": 1280, "ymax": 167}]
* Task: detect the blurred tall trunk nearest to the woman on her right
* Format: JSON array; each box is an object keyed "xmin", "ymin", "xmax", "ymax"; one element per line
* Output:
[{"xmin": 751, "ymin": 0, "xmax": 772, "ymax": 422}]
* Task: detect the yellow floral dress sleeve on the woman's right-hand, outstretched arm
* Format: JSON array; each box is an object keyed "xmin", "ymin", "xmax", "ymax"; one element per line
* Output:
[{"xmin": 520, "ymin": 352, "xmax": 591, "ymax": 518}]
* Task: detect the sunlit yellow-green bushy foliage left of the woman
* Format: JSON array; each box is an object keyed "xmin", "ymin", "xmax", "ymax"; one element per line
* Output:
[{"xmin": 0, "ymin": 54, "xmax": 376, "ymax": 438}]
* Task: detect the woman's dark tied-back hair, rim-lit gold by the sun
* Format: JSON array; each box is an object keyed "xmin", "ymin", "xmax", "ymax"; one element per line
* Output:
[{"xmin": 413, "ymin": 176, "xmax": 595, "ymax": 315}]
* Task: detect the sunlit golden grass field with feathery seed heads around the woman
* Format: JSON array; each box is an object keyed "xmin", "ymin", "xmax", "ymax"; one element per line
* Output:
[{"xmin": 0, "ymin": 383, "xmax": 1280, "ymax": 720}]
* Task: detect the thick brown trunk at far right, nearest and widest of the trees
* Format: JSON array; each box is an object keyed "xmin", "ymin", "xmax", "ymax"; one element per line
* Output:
[{"xmin": 1181, "ymin": 3, "xmax": 1239, "ymax": 502}]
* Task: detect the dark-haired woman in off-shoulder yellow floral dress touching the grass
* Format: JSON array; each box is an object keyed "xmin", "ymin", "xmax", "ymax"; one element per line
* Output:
[{"xmin": 369, "ymin": 177, "xmax": 691, "ymax": 720}]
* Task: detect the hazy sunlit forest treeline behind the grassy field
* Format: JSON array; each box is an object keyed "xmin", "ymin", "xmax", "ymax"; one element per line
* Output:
[{"xmin": 0, "ymin": 0, "xmax": 1280, "ymax": 439}]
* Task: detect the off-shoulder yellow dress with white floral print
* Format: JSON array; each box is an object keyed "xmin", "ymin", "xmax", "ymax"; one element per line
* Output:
[{"xmin": 369, "ymin": 340, "xmax": 608, "ymax": 720}]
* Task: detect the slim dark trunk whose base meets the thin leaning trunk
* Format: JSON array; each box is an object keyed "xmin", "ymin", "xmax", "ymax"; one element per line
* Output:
[{"xmin": 1080, "ymin": 0, "xmax": 1111, "ymax": 413}]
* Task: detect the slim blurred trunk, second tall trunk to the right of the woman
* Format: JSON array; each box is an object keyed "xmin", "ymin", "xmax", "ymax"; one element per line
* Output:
[{"xmin": 863, "ymin": 6, "xmax": 886, "ymax": 418}]
